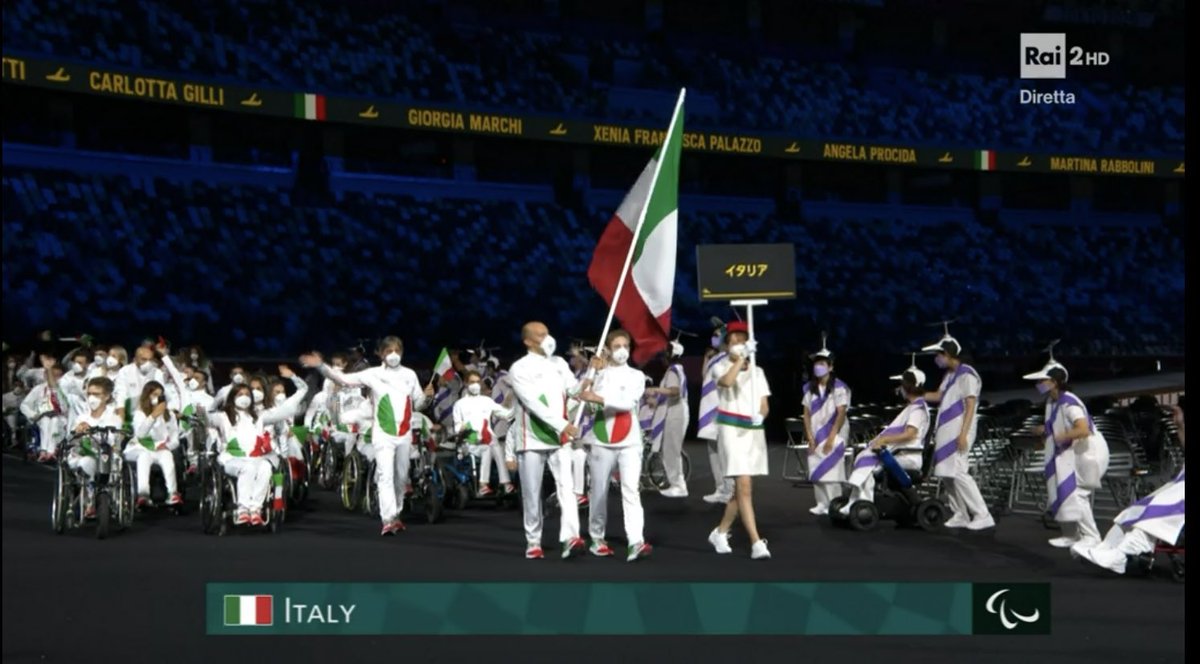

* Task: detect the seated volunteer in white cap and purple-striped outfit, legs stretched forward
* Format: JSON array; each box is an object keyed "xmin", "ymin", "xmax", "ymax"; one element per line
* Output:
[{"xmin": 841, "ymin": 366, "xmax": 929, "ymax": 509}]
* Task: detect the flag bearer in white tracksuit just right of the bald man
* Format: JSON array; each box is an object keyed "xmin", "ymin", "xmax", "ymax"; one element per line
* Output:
[{"xmin": 580, "ymin": 330, "xmax": 650, "ymax": 561}]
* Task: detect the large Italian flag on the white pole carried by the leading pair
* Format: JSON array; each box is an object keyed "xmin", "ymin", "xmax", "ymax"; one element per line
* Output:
[{"xmin": 588, "ymin": 90, "xmax": 685, "ymax": 364}]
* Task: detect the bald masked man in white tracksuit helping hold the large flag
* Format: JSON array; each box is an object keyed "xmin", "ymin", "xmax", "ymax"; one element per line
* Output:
[{"xmin": 505, "ymin": 321, "xmax": 588, "ymax": 558}]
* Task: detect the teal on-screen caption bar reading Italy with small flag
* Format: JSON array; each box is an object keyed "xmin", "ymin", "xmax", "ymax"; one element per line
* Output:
[{"xmin": 206, "ymin": 582, "xmax": 988, "ymax": 636}]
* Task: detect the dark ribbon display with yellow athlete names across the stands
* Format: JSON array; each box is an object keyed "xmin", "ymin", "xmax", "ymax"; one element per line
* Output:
[{"xmin": 0, "ymin": 53, "xmax": 1184, "ymax": 178}]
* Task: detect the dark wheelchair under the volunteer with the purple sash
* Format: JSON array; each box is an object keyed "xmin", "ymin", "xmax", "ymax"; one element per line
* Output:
[{"xmin": 829, "ymin": 448, "xmax": 948, "ymax": 532}]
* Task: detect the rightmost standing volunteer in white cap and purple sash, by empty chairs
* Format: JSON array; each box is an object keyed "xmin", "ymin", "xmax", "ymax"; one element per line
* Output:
[{"xmin": 1025, "ymin": 358, "xmax": 1109, "ymax": 549}]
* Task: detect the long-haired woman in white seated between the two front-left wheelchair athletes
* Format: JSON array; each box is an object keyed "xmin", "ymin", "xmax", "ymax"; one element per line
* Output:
[{"xmin": 125, "ymin": 382, "xmax": 184, "ymax": 506}]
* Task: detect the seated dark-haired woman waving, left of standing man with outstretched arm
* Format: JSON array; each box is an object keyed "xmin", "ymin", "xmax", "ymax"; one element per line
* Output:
[{"xmin": 209, "ymin": 366, "xmax": 308, "ymax": 526}]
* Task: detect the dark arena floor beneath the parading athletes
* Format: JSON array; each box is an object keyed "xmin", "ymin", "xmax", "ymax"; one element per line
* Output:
[{"xmin": 2, "ymin": 444, "xmax": 1184, "ymax": 664}]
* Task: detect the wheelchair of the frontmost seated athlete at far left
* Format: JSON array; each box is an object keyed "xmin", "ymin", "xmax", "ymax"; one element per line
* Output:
[{"xmin": 50, "ymin": 426, "xmax": 134, "ymax": 539}]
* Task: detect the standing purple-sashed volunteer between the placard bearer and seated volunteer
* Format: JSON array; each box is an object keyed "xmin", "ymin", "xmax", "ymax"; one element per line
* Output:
[{"xmin": 803, "ymin": 337, "xmax": 850, "ymax": 516}]
